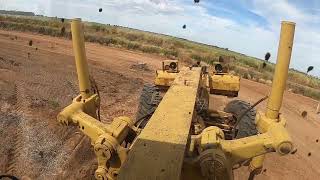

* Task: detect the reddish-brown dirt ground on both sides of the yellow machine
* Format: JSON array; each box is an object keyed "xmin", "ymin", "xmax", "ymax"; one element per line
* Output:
[{"xmin": 0, "ymin": 31, "xmax": 320, "ymax": 179}]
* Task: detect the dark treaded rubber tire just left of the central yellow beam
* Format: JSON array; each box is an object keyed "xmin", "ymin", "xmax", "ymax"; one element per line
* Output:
[{"xmin": 136, "ymin": 84, "xmax": 162, "ymax": 128}]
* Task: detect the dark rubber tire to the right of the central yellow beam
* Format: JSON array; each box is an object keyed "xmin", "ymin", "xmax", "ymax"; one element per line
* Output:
[{"xmin": 224, "ymin": 100, "xmax": 258, "ymax": 139}]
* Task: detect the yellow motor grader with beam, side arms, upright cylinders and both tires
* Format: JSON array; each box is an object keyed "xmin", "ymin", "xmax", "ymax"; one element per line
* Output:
[{"xmin": 57, "ymin": 19, "xmax": 295, "ymax": 180}]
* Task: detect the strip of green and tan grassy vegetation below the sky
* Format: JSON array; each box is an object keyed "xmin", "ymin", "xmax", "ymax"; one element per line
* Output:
[{"xmin": 0, "ymin": 15, "xmax": 320, "ymax": 100}]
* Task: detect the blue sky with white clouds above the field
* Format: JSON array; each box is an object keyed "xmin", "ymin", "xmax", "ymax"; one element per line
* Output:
[{"xmin": 0, "ymin": 0, "xmax": 320, "ymax": 77}]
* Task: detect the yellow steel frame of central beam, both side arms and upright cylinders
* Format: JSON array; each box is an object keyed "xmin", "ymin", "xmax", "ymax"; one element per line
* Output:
[{"xmin": 57, "ymin": 19, "xmax": 294, "ymax": 179}]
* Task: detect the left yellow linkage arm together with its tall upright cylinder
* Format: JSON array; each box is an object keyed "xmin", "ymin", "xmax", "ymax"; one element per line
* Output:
[{"xmin": 57, "ymin": 19, "xmax": 134, "ymax": 179}]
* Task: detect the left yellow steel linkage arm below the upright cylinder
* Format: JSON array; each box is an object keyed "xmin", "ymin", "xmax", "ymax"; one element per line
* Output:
[{"xmin": 57, "ymin": 94, "xmax": 134, "ymax": 179}]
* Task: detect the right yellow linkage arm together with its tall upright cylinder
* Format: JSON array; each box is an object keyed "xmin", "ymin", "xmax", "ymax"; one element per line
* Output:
[{"xmin": 191, "ymin": 22, "xmax": 295, "ymax": 179}]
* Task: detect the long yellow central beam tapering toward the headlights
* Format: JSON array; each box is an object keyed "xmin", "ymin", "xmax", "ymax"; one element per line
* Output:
[{"xmin": 118, "ymin": 68, "xmax": 201, "ymax": 180}]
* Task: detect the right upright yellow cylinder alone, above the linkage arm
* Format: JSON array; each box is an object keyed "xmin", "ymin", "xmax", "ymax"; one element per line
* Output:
[{"xmin": 266, "ymin": 21, "xmax": 295, "ymax": 119}]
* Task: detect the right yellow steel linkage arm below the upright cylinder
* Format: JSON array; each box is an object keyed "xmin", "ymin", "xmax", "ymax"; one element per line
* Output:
[{"xmin": 190, "ymin": 113, "xmax": 293, "ymax": 180}]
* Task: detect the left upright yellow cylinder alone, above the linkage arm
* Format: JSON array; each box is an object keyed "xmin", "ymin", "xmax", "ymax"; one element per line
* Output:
[{"xmin": 71, "ymin": 19, "xmax": 92, "ymax": 99}]
